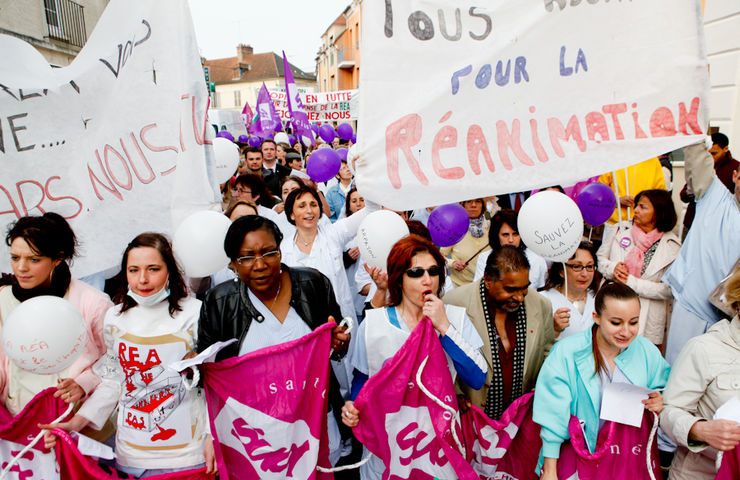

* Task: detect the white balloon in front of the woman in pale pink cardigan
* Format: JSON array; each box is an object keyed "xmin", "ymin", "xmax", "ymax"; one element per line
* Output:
[{"xmin": 2, "ymin": 295, "xmax": 87, "ymax": 374}]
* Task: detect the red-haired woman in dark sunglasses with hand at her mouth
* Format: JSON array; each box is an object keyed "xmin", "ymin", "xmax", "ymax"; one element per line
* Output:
[{"xmin": 342, "ymin": 235, "xmax": 488, "ymax": 479}]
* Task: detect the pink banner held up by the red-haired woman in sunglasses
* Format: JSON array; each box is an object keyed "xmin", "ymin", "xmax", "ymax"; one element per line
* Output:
[{"xmin": 354, "ymin": 319, "xmax": 478, "ymax": 480}]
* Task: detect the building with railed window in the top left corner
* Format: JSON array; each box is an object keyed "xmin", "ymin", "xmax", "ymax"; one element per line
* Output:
[{"xmin": 0, "ymin": 0, "xmax": 108, "ymax": 67}]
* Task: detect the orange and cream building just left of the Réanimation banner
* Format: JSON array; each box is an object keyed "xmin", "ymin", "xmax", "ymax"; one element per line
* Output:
[{"xmin": 316, "ymin": 0, "xmax": 362, "ymax": 92}]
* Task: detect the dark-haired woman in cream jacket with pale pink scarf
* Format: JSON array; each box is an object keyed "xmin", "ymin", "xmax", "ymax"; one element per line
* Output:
[{"xmin": 597, "ymin": 190, "xmax": 681, "ymax": 345}]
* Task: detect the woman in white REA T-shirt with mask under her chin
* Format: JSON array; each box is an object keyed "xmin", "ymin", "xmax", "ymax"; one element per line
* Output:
[{"xmin": 42, "ymin": 233, "xmax": 216, "ymax": 478}]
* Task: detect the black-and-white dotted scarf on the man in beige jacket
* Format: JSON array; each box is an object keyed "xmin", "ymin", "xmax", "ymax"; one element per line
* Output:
[{"xmin": 480, "ymin": 280, "xmax": 527, "ymax": 420}]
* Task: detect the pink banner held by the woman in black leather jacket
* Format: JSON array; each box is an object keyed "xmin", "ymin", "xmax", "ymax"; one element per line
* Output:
[{"xmin": 201, "ymin": 322, "xmax": 336, "ymax": 480}]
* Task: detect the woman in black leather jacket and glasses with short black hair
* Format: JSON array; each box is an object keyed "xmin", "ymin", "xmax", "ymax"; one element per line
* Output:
[{"xmin": 197, "ymin": 215, "xmax": 351, "ymax": 464}]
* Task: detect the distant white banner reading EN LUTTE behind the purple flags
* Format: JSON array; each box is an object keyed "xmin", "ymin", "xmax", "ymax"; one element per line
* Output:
[{"xmin": 270, "ymin": 90, "xmax": 359, "ymax": 122}]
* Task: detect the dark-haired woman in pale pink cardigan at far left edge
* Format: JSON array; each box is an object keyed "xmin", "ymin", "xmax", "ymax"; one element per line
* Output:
[{"xmin": 0, "ymin": 212, "xmax": 112, "ymax": 415}]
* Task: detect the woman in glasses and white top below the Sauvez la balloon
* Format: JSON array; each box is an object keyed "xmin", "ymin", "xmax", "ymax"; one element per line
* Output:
[{"xmin": 540, "ymin": 242, "xmax": 598, "ymax": 340}]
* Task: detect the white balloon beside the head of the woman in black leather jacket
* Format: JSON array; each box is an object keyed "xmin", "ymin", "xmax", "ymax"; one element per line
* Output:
[{"xmin": 172, "ymin": 210, "xmax": 231, "ymax": 278}]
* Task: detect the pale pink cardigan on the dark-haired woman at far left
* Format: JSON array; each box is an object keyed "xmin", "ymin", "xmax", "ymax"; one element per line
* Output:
[{"xmin": 0, "ymin": 279, "xmax": 113, "ymax": 405}]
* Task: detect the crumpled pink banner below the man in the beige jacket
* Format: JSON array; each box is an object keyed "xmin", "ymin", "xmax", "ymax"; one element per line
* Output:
[{"xmin": 461, "ymin": 393, "xmax": 542, "ymax": 480}]
